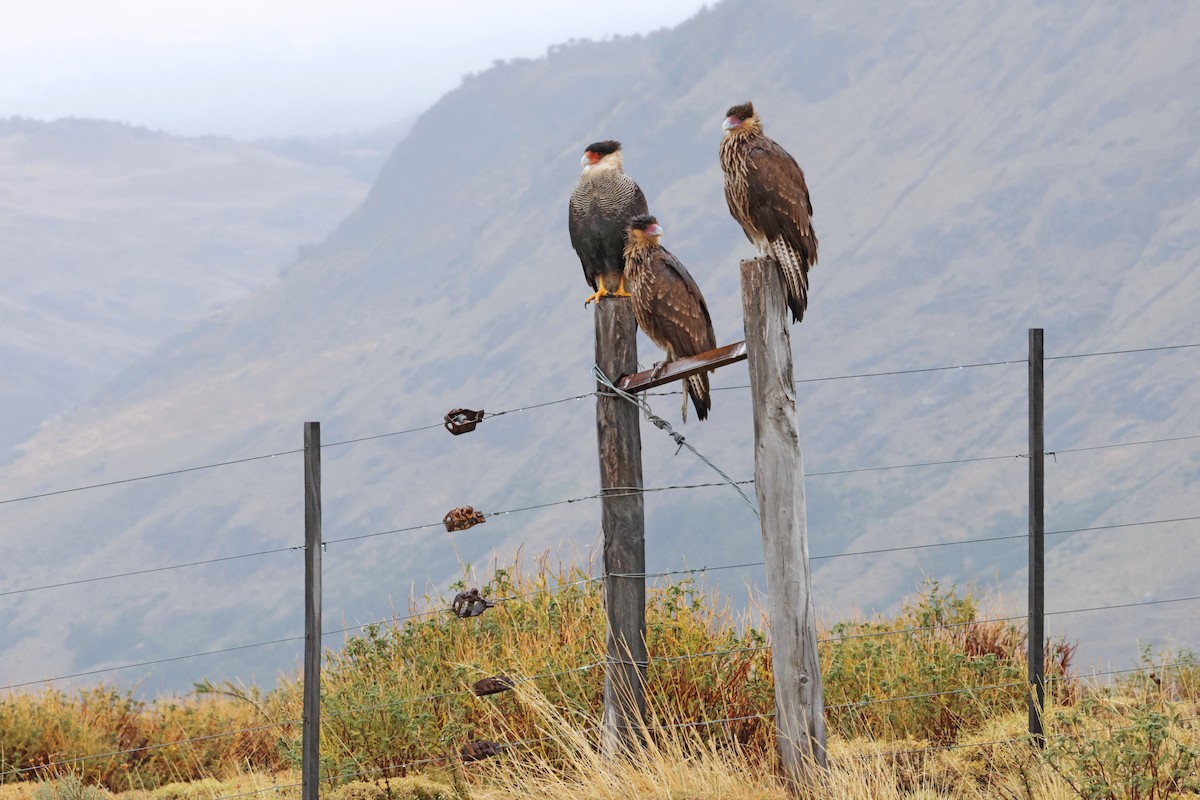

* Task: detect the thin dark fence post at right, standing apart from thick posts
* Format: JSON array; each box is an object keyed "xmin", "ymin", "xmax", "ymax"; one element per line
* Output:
[{"xmin": 1026, "ymin": 327, "xmax": 1046, "ymax": 747}]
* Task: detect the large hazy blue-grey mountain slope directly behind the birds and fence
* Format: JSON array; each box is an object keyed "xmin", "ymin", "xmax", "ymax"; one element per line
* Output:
[{"xmin": 0, "ymin": 0, "xmax": 1200, "ymax": 691}]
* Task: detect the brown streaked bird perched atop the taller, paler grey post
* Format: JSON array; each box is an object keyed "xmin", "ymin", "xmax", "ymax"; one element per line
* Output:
[{"xmin": 721, "ymin": 103, "xmax": 817, "ymax": 323}]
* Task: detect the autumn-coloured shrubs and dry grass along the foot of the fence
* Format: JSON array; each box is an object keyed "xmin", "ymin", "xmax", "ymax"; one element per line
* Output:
[{"xmin": 0, "ymin": 563, "xmax": 1200, "ymax": 800}]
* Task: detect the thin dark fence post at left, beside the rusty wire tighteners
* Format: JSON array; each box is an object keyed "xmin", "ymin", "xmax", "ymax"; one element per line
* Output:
[{"xmin": 300, "ymin": 422, "xmax": 322, "ymax": 800}]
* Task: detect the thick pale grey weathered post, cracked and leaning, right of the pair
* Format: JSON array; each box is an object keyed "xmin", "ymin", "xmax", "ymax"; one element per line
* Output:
[{"xmin": 742, "ymin": 258, "xmax": 827, "ymax": 793}]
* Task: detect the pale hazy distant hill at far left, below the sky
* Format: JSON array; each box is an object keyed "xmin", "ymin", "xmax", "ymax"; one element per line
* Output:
[{"xmin": 0, "ymin": 119, "xmax": 379, "ymax": 461}]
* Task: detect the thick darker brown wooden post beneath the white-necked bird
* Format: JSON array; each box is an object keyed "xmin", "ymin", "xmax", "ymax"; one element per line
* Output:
[{"xmin": 595, "ymin": 297, "xmax": 647, "ymax": 756}]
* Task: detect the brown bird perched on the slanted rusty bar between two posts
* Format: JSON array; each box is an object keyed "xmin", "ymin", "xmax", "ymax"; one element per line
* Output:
[{"xmin": 625, "ymin": 213, "xmax": 716, "ymax": 422}]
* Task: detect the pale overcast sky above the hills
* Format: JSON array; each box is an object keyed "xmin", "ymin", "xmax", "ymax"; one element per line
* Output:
[{"xmin": 0, "ymin": 0, "xmax": 704, "ymax": 138}]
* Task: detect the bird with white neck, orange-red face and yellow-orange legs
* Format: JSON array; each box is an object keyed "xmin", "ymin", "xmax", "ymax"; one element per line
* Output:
[{"xmin": 566, "ymin": 139, "xmax": 649, "ymax": 306}]
